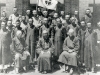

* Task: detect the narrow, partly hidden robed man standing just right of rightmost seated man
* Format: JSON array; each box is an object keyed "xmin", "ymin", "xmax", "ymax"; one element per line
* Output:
[{"xmin": 78, "ymin": 21, "xmax": 86, "ymax": 66}]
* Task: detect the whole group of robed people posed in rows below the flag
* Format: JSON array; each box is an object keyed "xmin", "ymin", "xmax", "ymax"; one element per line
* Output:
[{"xmin": 0, "ymin": 7, "xmax": 100, "ymax": 74}]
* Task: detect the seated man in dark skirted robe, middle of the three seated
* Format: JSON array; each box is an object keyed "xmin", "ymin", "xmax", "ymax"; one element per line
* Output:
[{"xmin": 37, "ymin": 30, "xmax": 53, "ymax": 74}]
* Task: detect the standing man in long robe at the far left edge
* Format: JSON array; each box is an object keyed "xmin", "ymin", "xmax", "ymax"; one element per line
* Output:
[{"xmin": 0, "ymin": 22, "xmax": 11, "ymax": 73}]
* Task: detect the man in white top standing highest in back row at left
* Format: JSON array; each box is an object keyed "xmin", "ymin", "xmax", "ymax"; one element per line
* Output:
[{"xmin": 9, "ymin": 7, "xmax": 19, "ymax": 26}]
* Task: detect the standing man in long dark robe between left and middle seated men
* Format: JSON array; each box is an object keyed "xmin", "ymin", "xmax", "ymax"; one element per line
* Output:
[{"xmin": 26, "ymin": 19, "xmax": 38, "ymax": 64}]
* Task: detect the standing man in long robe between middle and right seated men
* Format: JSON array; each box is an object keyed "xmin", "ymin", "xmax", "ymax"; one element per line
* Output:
[{"xmin": 54, "ymin": 19, "xmax": 66, "ymax": 67}]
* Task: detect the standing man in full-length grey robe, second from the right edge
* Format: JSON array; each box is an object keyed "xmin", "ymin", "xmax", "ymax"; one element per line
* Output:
[{"xmin": 84, "ymin": 22, "xmax": 97, "ymax": 72}]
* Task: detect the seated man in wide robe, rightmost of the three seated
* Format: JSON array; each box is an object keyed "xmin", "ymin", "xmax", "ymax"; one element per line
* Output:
[{"xmin": 58, "ymin": 29, "xmax": 79, "ymax": 73}]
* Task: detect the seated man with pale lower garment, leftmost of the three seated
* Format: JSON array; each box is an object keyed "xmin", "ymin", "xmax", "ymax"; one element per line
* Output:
[{"xmin": 12, "ymin": 30, "xmax": 30, "ymax": 73}]
